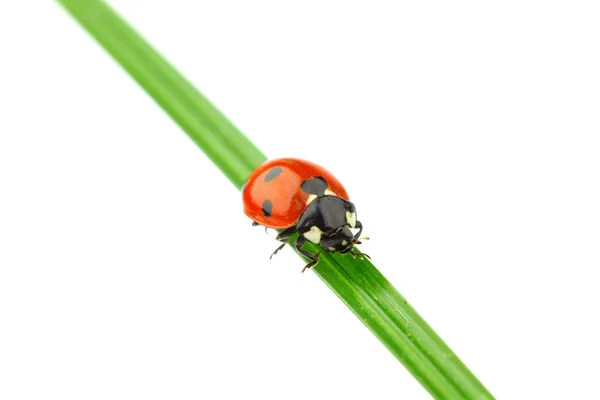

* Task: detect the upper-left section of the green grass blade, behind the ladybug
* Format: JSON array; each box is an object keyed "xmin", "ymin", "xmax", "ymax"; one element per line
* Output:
[{"xmin": 60, "ymin": 0, "xmax": 266, "ymax": 188}]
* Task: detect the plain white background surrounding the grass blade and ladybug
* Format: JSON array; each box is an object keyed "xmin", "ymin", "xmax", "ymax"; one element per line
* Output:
[{"xmin": 0, "ymin": 0, "xmax": 600, "ymax": 400}]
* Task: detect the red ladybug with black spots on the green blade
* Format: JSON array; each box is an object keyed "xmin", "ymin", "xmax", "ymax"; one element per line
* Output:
[{"xmin": 242, "ymin": 158, "xmax": 370, "ymax": 272}]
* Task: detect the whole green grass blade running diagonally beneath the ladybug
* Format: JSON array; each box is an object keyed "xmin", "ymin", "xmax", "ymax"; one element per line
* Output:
[{"xmin": 58, "ymin": 0, "xmax": 493, "ymax": 399}]
